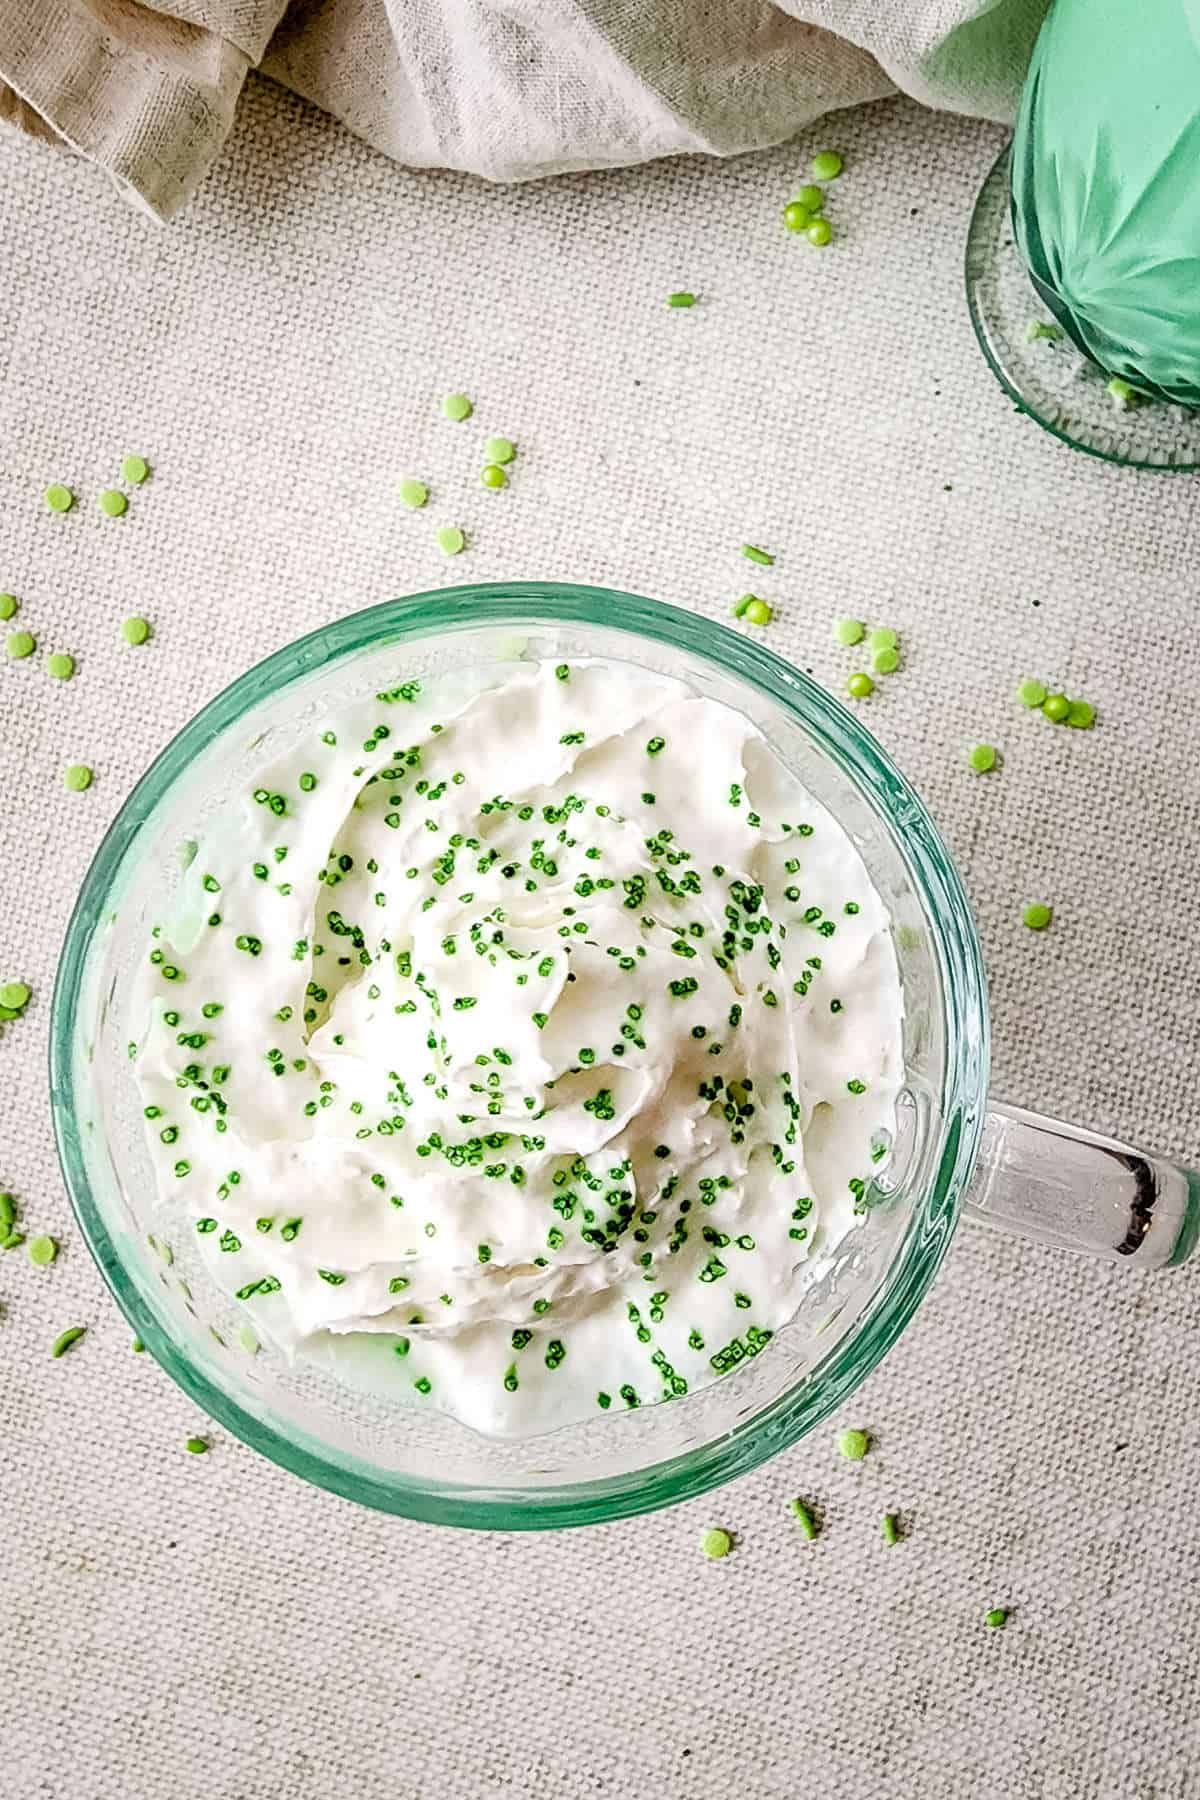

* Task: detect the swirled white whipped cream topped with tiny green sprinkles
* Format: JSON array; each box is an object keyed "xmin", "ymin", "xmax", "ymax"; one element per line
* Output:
[{"xmin": 131, "ymin": 662, "xmax": 901, "ymax": 1436}]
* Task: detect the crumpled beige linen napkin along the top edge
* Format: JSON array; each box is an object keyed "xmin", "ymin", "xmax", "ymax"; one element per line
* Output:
[{"xmin": 0, "ymin": 0, "xmax": 1047, "ymax": 218}]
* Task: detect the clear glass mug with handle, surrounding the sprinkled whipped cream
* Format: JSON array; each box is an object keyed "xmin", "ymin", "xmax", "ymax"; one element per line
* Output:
[{"xmin": 50, "ymin": 581, "xmax": 1200, "ymax": 1528}]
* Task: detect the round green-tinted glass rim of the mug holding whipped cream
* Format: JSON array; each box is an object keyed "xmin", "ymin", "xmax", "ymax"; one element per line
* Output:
[{"xmin": 50, "ymin": 581, "xmax": 988, "ymax": 1530}]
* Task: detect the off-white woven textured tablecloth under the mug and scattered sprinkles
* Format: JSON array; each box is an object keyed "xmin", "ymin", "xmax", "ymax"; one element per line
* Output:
[{"xmin": 0, "ymin": 77, "xmax": 1200, "ymax": 1800}]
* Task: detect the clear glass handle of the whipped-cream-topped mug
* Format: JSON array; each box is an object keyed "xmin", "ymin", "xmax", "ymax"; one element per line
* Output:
[{"xmin": 963, "ymin": 1102, "xmax": 1200, "ymax": 1269}]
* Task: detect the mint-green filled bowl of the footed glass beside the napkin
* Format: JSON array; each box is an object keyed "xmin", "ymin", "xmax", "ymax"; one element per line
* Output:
[{"xmin": 1013, "ymin": 0, "xmax": 1200, "ymax": 407}]
